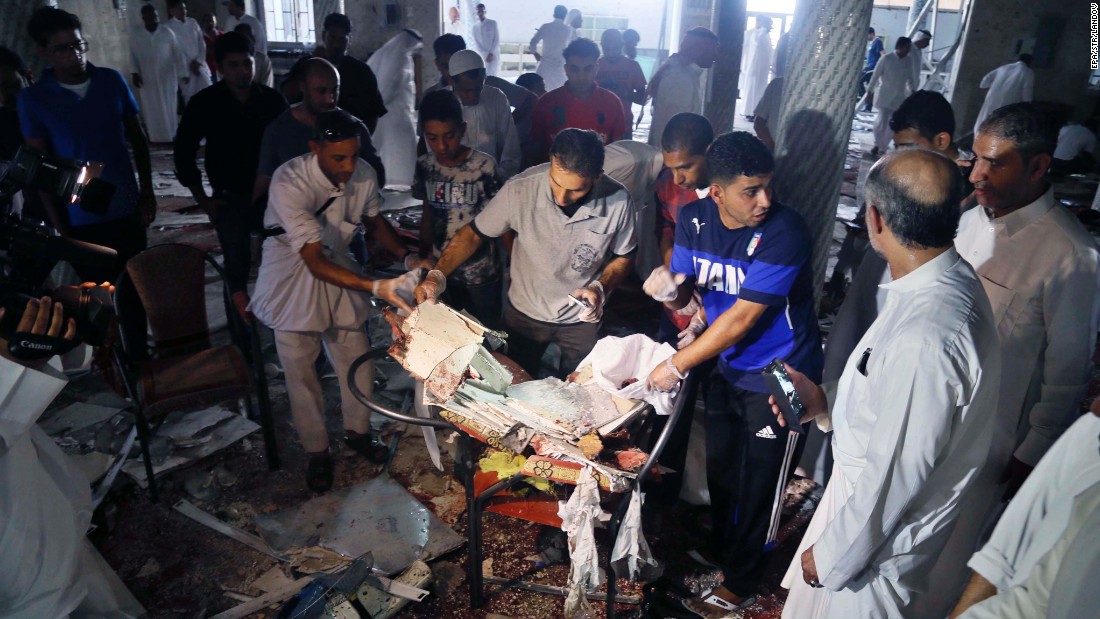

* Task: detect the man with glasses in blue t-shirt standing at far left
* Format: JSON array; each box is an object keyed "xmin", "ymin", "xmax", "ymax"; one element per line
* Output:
[{"xmin": 19, "ymin": 7, "xmax": 156, "ymax": 281}]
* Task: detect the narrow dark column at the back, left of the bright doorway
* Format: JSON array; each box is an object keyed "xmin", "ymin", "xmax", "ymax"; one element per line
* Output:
[{"xmin": 704, "ymin": 0, "xmax": 748, "ymax": 134}]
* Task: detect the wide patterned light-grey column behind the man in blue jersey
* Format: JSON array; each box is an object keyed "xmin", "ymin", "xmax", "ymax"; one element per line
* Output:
[{"xmin": 772, "ymin": 0, "xmax": 872, "ymax": 292}]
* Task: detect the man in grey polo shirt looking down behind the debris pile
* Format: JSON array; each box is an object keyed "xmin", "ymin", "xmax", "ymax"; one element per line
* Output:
[{"xmin": 416, "ymin": 129, "xmax": 638, "ymax": 377}]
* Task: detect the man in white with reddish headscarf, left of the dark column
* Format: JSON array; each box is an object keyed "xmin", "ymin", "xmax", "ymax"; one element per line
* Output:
[{"xmin": 649, "ymin": 27, "xmax": 718, "ymax": 146}]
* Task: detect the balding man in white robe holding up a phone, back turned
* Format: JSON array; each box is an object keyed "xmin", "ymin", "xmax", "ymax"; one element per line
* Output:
[{"xmin": 772, "ymin": 151, "xmax": 1001, "ymax": 619}]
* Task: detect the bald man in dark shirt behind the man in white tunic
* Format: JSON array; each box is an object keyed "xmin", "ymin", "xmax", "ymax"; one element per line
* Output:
[{"xmin": 252, "ymin": 57, "xmax": 420, "ymax": 273}]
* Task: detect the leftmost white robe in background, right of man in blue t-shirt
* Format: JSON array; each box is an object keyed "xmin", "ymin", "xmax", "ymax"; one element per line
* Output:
[{"xmin": 130, "ymin": 25, "xmax": 187, "ymax": 142}]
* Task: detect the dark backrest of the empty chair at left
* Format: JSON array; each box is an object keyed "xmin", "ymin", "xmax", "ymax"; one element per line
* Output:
[{"xmin": 125, "ymin": 243, "xmax": 210, "ymax": 352}]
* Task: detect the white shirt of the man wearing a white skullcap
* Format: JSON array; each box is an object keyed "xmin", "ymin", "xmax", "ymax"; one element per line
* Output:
[{"xmin": 459, "ymin": 86, "xmax": 523, "ymax": 179}]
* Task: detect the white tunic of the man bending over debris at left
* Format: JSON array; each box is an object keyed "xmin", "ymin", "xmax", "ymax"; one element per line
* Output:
[{"xmin": 249, "ymin": 153, "xmax": 381, "ymax": 333}]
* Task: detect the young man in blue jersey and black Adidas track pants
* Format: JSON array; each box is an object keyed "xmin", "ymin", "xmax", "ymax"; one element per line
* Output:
[{"xmin": 645, "ymin": 131, "xmax": 823, "ymax": 617}]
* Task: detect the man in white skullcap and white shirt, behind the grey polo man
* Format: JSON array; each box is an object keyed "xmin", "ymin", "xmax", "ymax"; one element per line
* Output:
[{"xmin": 448, "ymin": 49, "xmax": 523, "ymax": 179}]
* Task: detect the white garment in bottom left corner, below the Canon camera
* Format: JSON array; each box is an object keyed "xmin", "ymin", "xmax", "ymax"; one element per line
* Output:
[{"xmin": 0, "ymin": 357, "xmax": 144, "ymax": 619}]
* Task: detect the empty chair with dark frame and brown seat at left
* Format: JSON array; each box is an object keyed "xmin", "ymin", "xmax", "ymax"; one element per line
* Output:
[{"xmin": 114, "ymin": 244, "xmax": 278, "ymax": 501}]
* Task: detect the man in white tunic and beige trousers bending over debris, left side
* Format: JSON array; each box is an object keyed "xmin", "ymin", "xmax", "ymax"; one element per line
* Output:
[{"xmin": 249, "ymin": 110, "xmax": 418, "ymax": 493}]
